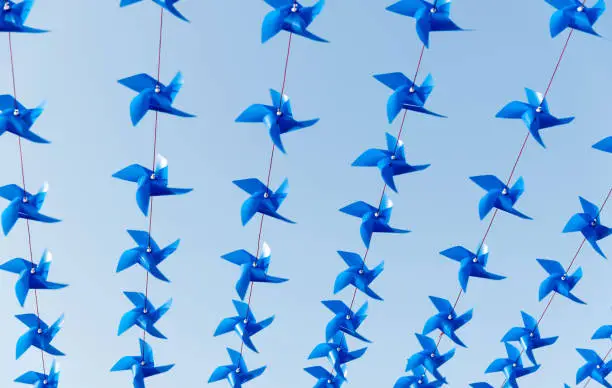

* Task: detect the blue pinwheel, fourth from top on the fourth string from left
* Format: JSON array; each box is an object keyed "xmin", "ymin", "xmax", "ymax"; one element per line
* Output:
[{"xmin": 340, "ymin": 194, "xmax": 410, "ymax": 248}]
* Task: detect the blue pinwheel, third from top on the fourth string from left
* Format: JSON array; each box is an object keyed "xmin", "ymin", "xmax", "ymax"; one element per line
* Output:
[{"xmin": 352, "ymin": 133, "xmax": 430, "ymax": 192}]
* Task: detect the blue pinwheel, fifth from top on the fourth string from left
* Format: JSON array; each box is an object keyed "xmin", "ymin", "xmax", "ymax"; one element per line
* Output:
[{"xmin": 334, "ymin": 251, "xmax": 385, "ymax": 300}]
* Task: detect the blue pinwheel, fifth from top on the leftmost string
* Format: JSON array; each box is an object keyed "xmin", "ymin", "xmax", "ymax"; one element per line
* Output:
[{"xmin": 15, "ymin": 314, "xmax": 64, "ymax": 359}]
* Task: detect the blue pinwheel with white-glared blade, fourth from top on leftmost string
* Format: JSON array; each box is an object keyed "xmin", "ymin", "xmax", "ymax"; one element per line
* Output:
[{"xmin": 0, "ymin": 250, "xmax": 68, "ymax": 307}]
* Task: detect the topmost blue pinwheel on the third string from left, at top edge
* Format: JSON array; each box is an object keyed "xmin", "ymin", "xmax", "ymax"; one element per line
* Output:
[{"xmin": 261, "ymin": 0, "xmax": 327, "ymax": 43}]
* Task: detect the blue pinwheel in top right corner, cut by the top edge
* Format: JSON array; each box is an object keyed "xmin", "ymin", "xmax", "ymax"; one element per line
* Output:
[{"xmin": 546, "ymin": 0, "xmax": 606, "ymax": 38}]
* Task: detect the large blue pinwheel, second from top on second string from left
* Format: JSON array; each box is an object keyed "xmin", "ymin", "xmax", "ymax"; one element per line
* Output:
[{"xmin": 119, "ymin": 72, "xmax": 195, "ymax": 126}]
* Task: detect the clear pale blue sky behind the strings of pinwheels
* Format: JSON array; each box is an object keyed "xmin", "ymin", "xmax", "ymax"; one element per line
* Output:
[{"xmin": 0, "ymin": 0, "xmax": 612, "ymax": 388}]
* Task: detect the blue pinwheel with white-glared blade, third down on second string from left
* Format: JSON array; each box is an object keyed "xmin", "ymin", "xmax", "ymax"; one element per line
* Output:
[{"xmin": 113, "ymin": 155, "xmax": 193, "ymax": 216}]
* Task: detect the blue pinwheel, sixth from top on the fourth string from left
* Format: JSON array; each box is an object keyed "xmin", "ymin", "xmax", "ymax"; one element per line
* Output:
[{"xmin": 321, "ymin": 300, "xmax": 372, "ymax": 343}]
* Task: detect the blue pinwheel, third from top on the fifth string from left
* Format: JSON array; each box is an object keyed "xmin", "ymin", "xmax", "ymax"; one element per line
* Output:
[{"xmin": 470, "ymin": 175, "xmax": 532, "ymax": 220}]
